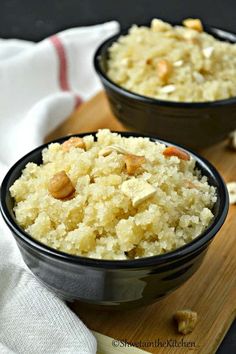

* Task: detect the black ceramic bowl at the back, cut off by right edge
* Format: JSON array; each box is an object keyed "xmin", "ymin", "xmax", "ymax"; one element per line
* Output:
[{"xmin": 94, "ymin": 23, "xmax": 236, "ymax": 150}]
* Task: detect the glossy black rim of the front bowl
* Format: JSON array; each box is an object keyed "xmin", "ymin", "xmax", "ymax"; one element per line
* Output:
[{"xmin": 0, "ymin": 131, "xmax": 229, "ymax": 269}]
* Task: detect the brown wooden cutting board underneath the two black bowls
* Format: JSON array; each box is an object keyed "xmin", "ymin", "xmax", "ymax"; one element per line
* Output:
[{"xmin": 48, "ymin": 92, "xmax": 236, "ymax": 354}]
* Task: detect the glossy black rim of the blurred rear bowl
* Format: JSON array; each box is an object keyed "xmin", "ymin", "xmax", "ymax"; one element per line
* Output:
[{"xmin": 93, "ymin": 21, "xmax": 236, "ymax": 108}]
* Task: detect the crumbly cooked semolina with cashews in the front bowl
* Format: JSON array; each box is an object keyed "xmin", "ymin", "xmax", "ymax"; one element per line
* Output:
[{"xmin": 10, "ymin": 129, "xmax": 216, "ymax": 260}]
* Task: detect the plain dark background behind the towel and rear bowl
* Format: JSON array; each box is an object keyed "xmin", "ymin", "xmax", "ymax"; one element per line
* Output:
[{"xmin": 0, "ymin": 0, "xmax": 236, "ymax": 354}]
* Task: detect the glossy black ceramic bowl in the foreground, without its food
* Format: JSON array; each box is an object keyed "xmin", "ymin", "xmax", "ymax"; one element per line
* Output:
[{"xmin": 1, "ymin": 133, "xmax": 229, "ymax": 308}]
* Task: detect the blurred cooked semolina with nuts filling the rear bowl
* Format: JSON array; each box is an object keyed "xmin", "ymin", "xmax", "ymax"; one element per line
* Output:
[{"xmin": 107, "ymin": 19, "xmax": 236, "ymax": 102}]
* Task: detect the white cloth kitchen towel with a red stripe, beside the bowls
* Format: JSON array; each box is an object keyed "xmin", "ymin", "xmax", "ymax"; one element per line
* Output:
[{"xmin": 0, "ymin": 21, "xmax": 119, "ymax": 354}]
